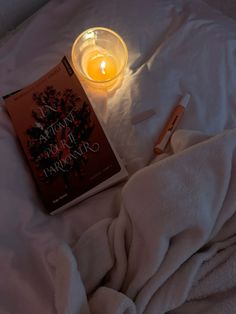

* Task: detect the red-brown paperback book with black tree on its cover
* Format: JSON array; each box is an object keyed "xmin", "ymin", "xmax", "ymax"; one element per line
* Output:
[{"xmin": 4, "ymin": 57, "xmax": 127, "ymax": 214}]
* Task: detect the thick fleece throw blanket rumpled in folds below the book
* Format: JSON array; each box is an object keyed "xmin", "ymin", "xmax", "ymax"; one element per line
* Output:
[{"xmin": 49, "ymin": 129, "xmax": 236, "ymax": 314}]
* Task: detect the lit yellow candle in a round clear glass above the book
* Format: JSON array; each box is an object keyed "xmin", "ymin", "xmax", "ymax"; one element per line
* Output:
[{"xmin": 72, "ymin": 27, "xmax": 128, "ymax": 88}]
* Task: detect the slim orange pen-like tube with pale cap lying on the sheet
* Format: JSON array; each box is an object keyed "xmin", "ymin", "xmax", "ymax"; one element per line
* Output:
[{"xmin": 154, "ymin": 94, "xmax": 190, "ymax": 154}]
